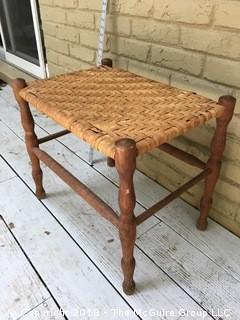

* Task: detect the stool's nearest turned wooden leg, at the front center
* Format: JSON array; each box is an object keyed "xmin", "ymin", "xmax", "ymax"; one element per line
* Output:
[{"xmin": 115, "ymin": 139, "xmax": 137, "ymax": 295}]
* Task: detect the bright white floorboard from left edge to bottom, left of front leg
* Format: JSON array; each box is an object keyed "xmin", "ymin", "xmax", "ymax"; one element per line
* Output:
[{"xmin": 0, "ymin": 178, "xmax": 139, "ymax": 320}]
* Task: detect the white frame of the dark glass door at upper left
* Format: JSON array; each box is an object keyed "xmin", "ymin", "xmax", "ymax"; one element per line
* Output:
[{"xmin": 0, "ymin": 0, "xmax": 46, "ymax": 78}]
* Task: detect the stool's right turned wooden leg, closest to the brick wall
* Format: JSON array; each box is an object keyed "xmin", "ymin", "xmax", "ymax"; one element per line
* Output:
[{"xmin": 197, "ymin": 96, "xmax": 236, "ymax": 231}]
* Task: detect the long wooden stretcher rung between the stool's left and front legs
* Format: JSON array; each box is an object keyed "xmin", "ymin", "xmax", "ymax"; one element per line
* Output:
[{"xmin": 32, "ymin": 148, "xmax": 118, "ymax": 227}]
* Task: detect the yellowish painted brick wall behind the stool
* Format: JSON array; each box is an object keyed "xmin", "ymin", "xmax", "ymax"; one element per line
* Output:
[{"xmin": 39, "ymin": 0, "xmax": 240, "ymax": 235}]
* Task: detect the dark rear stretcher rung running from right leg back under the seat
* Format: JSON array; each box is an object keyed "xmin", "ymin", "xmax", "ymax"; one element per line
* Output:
[{"xmin": 159, "ymin": 143, "xmax": 206, "ymax": 170}]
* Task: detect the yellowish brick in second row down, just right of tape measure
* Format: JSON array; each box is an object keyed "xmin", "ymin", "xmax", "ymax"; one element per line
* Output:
[{"xmin": 132, "ymin": 19, "xmax": 179, "ymax": 44}]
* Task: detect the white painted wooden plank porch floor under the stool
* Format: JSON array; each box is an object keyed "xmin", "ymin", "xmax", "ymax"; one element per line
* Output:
[{"xmin": 0, "ymin": 87, "xmax": 240, "ymax": 320}]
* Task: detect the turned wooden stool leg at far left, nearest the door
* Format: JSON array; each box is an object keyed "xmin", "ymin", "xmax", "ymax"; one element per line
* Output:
[{"xmin": 12, "ymin": 79, "xmax": 46, "ymax": 199}]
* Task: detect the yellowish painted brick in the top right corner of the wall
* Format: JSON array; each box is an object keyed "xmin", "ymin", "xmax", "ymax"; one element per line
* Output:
[{"xmin": 215, "ymin": 1, "xmax": 240, "ymax": 29}]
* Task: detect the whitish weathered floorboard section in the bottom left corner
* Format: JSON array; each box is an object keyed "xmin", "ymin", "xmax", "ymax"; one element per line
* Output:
[{"xmin": 0, "ymin": 219, "xmax": 50, "ymax": 320}]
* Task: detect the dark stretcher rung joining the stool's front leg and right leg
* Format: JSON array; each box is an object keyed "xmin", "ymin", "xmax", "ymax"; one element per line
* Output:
[{"xmin": 136, "ymin": 169, "xmax": 212, "ymax": 225}]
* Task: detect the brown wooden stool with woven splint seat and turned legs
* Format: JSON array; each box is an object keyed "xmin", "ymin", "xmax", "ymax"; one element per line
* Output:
[{"xmin": 13, "ymin": 59, "xmax": 236, "ymax": 294}]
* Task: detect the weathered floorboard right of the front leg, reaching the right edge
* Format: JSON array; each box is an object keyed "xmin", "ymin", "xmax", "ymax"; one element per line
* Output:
[{"xmin": 137, "ymin": 224, "xmax": 240, "ymax": 320}]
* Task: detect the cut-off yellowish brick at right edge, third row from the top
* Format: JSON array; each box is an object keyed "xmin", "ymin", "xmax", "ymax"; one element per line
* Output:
[{"xmin": 204, "ymin": 57, "xmax": 240, "ymax": 87}]
